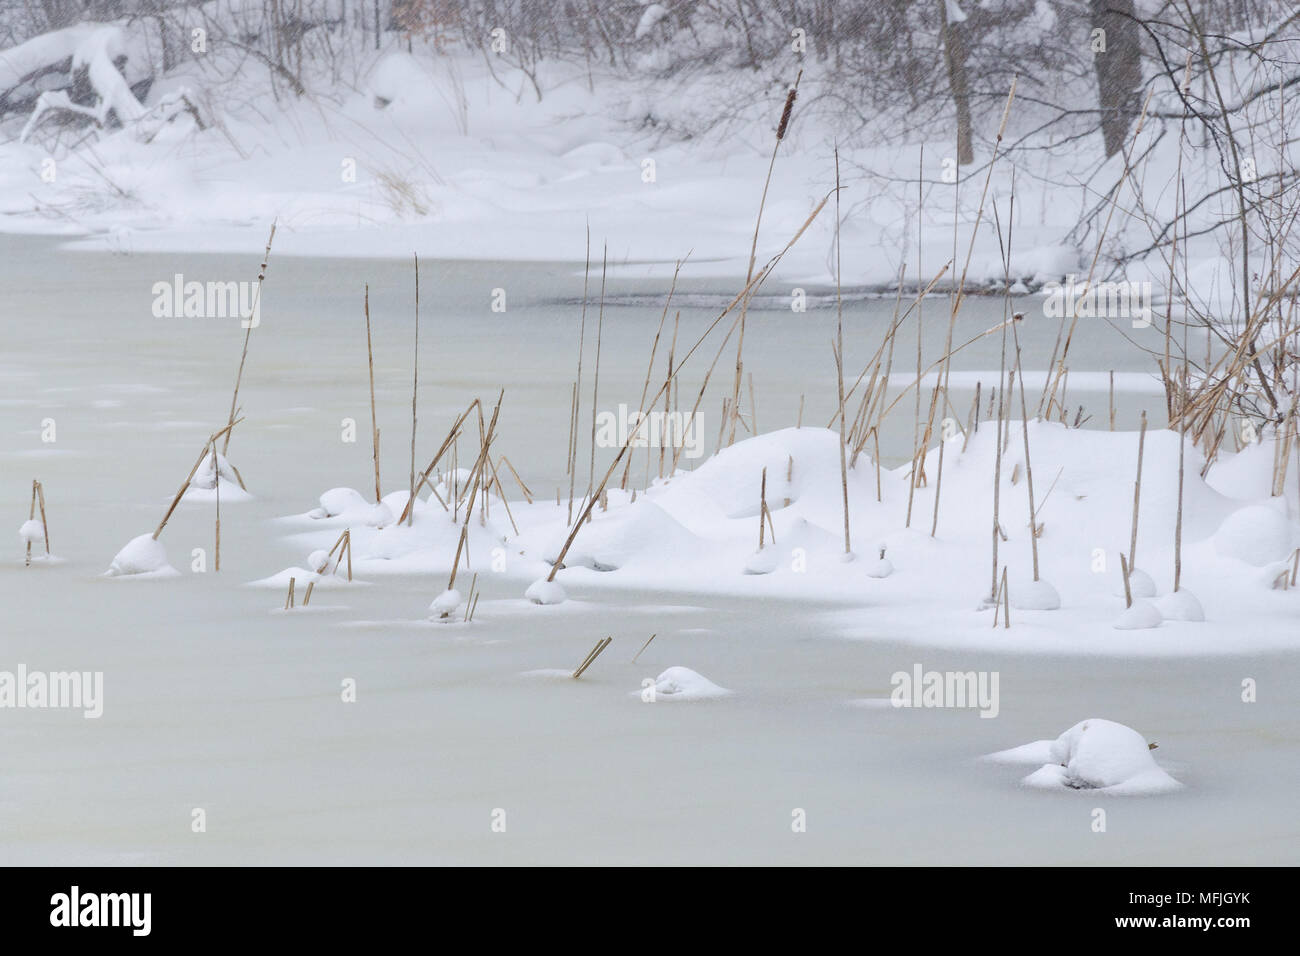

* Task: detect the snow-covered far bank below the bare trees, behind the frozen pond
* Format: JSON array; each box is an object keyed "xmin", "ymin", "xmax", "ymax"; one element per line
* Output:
[{"xmin": 0, "ymin": 27, "xmax": 1258, "ymax": 304}]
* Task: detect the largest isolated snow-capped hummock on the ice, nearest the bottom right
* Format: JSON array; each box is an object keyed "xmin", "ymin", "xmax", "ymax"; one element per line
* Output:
[{"xmin": 987, "ymin": 717, "xmax": 1183, "ymax": 793}]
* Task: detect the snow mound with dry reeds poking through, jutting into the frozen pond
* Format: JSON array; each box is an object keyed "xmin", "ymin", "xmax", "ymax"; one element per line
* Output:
[{"xmin": 273, "ymin": 423, "xmax": 1300, "ymax": 656}]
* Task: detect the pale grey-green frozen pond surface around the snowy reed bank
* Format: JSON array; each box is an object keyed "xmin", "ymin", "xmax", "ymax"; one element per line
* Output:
[{"xmin": 0, "ymin": 238, "xmax": 1300, "ymax": 865}]
